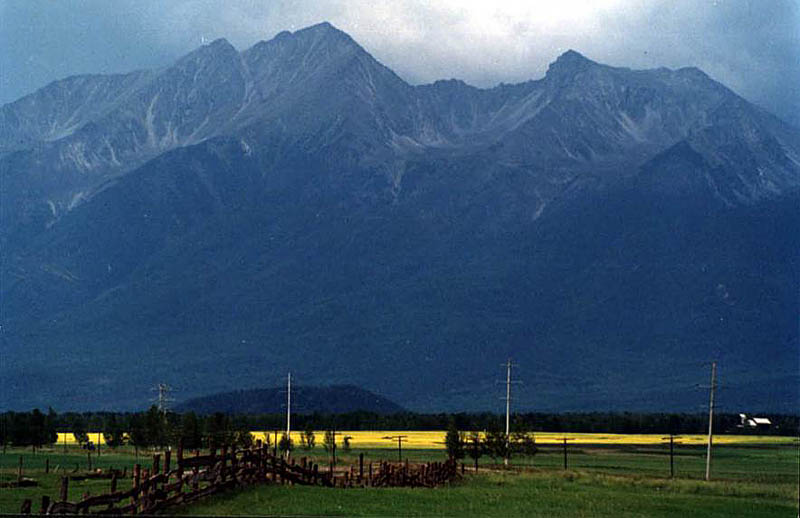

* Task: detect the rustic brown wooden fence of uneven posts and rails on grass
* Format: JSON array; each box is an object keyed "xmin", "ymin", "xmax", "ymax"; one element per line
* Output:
[{"xmin": 20, "ymin": 441, "xmax": 463, "ymax": 515}]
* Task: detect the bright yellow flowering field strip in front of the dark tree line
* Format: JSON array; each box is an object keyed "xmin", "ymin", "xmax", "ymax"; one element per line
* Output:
[{"xmin": 58, "ymin": 430, "xmax": 797, "ymax": 449}]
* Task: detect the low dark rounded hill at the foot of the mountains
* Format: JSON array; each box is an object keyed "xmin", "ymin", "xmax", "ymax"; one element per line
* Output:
[{"xmin": 175, "ymin": 385, "xmax": 404, "ymax": 414}]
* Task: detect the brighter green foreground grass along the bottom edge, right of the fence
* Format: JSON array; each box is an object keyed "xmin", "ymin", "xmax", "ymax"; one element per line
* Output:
[{"xmin": 177, "ymin": 470, "xmax": 797, "ymax": 518}]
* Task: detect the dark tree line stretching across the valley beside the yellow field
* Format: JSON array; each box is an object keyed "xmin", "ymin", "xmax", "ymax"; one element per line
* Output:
[{"xmin": 0, "ymin": 406, "xmax": 800, "ymax": 449}]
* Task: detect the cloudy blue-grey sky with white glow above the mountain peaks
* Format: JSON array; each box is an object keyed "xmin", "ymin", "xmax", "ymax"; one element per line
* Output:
[{"xmin": 0, "ymin": 0, "xmax": 800, "ymax": 123}]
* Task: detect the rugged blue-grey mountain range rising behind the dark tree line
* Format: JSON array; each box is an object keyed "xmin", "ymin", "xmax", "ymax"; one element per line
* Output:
[{"xmin": 0, "ymin": 24, "xmax": 800, "ymax": 411}]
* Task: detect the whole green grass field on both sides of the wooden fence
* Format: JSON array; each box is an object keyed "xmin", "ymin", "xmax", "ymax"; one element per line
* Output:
[{"xmin": 0, "ymin": 443, "xmax": 799, "ymax": 517}]
